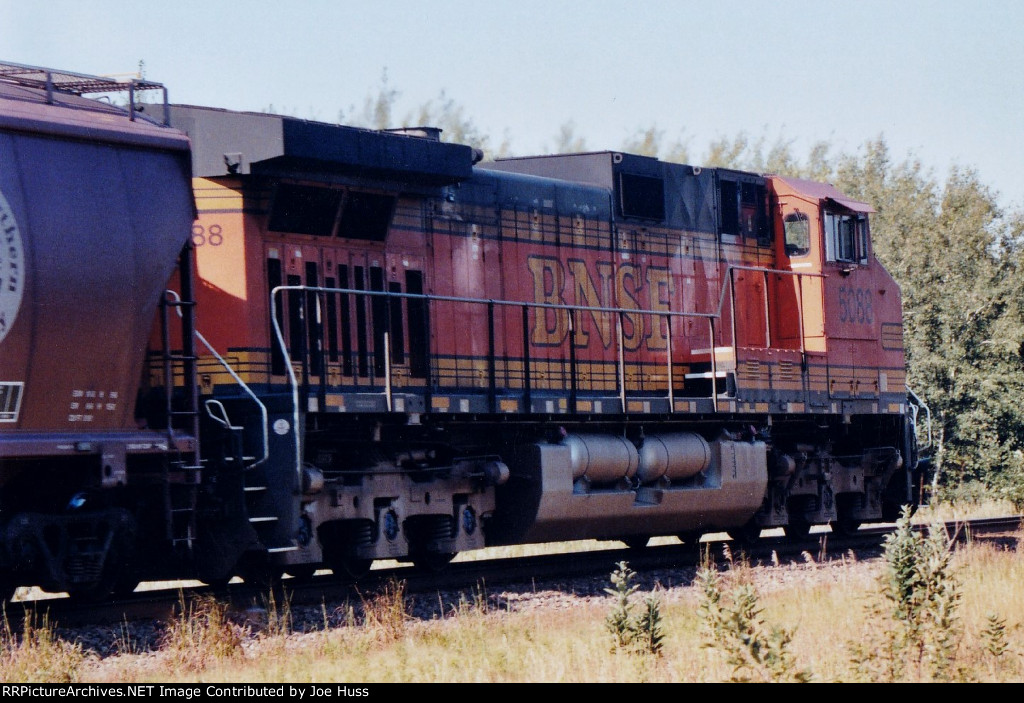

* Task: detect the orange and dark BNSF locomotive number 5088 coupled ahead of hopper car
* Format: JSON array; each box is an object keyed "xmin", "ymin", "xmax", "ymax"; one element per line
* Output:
[{"xmin": 146, "ymin": 106, "xmax": 920, "ymax": 580}]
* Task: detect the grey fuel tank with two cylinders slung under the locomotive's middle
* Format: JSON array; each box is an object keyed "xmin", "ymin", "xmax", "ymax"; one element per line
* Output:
[{"xmin": 492, "ymin": 433, "xmax": 768, "ymax": 543}]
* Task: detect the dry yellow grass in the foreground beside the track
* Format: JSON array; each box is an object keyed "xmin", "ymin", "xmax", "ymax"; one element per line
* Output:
[{"xmin": 9, "ymin": 497, "xmax": 1024, "ymax": 684}]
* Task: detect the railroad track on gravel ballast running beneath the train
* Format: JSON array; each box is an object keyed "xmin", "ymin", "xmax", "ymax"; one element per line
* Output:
[{"xmin": 6, "ymin": 516, "xmax": 1022, "ymax": 628}]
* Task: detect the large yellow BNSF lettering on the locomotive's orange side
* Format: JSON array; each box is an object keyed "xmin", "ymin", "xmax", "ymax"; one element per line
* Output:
[{"xmin": 526, "ymin": 256, "xmax": 675, "ymax": 351}]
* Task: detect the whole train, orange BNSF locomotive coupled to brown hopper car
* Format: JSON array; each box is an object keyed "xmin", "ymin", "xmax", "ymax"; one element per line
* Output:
[{"xmin": 0, "ymin": 63, "xmax": 920, "ymax": 597}]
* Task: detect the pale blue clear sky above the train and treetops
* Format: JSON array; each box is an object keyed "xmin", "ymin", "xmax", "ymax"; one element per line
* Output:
[{"xmin": 0, "ymin": 0, "xmax": 1024, "ymax": 209}]
